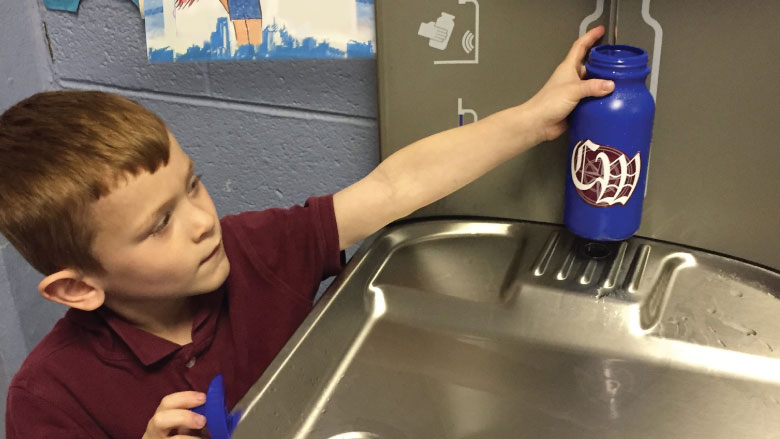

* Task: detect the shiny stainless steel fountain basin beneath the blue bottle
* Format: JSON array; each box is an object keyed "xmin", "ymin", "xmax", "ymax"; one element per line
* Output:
[{"xmin": 234, "ymin": 220, "xmax": 780, "ymax": 439}]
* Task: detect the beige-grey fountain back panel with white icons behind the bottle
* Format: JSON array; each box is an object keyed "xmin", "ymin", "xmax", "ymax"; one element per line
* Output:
[{"xmin": 376, "ymin": 0, "xmax": 780, "ymax": 270}]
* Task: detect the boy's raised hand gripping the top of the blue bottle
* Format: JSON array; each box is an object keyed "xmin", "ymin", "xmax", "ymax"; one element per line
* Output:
[{"xmin": 527, "ymin": 26, "xmax": 615, "ymax": 141}]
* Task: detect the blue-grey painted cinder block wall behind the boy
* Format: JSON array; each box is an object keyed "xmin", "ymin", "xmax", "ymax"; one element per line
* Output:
[{"xmin": 0, "ymin": 0, "xmax": 379, "ymax": 436}]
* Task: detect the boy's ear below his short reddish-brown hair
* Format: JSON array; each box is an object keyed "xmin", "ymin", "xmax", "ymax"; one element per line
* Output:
[{"xmin": 38, "ymin": 268, "xmax": 106, "ymax": 311}]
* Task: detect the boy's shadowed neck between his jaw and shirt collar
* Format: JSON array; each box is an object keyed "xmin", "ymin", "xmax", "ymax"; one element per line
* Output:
[{"xmin": 106, "ymin": 297, "xmax": 193, "ymax": 346}]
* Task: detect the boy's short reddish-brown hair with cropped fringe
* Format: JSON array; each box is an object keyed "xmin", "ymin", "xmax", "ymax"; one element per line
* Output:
[{"xmin": 0, "ymin": 91, "xmax": 170, "ymax": 275}]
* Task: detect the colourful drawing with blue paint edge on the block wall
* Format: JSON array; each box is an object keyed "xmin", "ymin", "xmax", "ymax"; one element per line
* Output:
[{"xmin": 146, "ymin": 0, "xmax": 376, "ymax": 62}]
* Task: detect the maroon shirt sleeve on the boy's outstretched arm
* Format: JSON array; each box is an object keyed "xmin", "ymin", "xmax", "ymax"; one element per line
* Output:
[{"xmin": 222, "ymin": 195, "xmax": 345, "ymax": 301}]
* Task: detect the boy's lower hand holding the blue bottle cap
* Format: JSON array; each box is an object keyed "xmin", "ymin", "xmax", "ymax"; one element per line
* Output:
[{"xmin": 142, "ymin": 391, "xmax": 206, "ymax": 439}]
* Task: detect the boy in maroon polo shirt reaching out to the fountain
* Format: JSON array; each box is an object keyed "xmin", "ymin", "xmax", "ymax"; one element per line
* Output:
[{"xmin": 0, "ymin": 27, "xmax": 614, "ymax": 439}]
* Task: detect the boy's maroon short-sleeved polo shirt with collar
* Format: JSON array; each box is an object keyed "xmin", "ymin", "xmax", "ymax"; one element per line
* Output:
[{"xmin": 6, "ymin": 196, "xmax": 343, "ymax": 439}]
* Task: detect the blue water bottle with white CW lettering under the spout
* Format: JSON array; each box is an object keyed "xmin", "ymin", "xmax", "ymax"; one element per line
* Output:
[{"xmin": 564, "ymin": 45, "xmax": 655, "ymax": 241}]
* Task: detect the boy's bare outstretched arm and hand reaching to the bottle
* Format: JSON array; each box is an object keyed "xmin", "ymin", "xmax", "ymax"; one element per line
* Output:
[{"xmin": 333, "ymin": 26, "xmax": 614, "ymax": 249}]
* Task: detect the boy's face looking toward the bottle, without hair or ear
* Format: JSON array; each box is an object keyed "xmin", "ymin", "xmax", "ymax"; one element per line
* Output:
[{"xmin": 91, "ymin": 134, "xmax": 230, "ymax": 306}]
